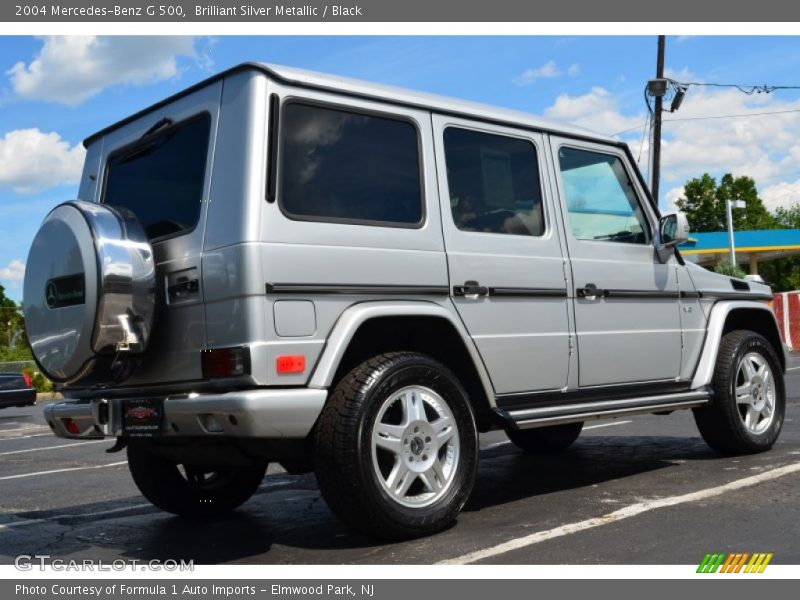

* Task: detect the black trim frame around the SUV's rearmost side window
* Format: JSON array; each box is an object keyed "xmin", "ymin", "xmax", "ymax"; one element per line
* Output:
[{"xmin": 276, "ymin": 96, "xmax": 428, "ymax": 229}]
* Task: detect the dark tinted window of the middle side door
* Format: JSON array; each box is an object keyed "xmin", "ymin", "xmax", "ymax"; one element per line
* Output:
[{"xmin": 444, "ymin": 127, "xmax": 544, "ymax": 236}]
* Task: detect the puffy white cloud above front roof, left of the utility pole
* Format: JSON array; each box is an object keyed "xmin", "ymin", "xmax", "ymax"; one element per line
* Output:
[{"xmin": 544, "ymin": 87, "xmax": 644, "ymax": 134}]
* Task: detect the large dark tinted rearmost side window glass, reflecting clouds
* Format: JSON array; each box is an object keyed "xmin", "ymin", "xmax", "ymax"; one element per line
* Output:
[{"xmin": 279, "ymin": 102, "xmax": 423, "ymax": 227}]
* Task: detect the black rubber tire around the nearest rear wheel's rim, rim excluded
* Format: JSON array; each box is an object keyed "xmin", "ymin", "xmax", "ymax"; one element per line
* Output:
[{"xmin": 315, "ymin": 352, "xmax": 478, "ymax": 539}]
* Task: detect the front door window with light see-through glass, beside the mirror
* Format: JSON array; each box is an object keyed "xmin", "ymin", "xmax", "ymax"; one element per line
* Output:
[{"xmin": 558, "ymin": 147, "xmax": 650, "ymax": 244}]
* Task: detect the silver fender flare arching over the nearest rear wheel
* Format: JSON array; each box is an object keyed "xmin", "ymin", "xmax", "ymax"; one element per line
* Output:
[{"xmin": 308, "ymin": 301, "xmax": 495, "ymax": 408}]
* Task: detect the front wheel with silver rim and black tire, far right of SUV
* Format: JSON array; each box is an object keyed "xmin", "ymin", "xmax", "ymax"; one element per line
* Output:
[{"xmin": 694, "ymin": 330, "xmax": 786, "ymax": 454}]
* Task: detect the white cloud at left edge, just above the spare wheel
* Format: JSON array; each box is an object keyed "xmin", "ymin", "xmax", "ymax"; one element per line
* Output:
[{"xmin": 0, "ymin": 129, "xmax": 86, "ymax": 194}]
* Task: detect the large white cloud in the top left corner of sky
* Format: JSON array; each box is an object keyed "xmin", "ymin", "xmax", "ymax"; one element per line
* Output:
[{"xmin": 7, "ymin": 36, "xmax": 195, "ymax": 106}]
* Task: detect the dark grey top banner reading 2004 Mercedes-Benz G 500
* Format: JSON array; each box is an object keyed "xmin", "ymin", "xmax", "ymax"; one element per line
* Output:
[{"xmin": 0, "ymin": 0, "xmax": 800, "ymax": 22}]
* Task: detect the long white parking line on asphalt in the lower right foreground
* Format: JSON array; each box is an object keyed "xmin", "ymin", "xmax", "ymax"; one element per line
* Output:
[{"xmin": 437, "ymin": 463, "xmax": 800, "ymax": 565}]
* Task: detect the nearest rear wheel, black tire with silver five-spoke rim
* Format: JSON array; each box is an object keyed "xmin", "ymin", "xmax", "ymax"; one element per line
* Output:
[{"xmin": 315, "ymin": 352, "xmax": 478, "ymax": 539}]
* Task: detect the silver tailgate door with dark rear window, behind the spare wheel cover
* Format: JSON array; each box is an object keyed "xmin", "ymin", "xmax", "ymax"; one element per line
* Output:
[{"xmin": 96, "ymin": 82, "xmax": 222, "ymax": 386}]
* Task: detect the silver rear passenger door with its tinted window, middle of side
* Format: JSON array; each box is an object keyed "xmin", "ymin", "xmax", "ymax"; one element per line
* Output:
[{"xmin": 433, "ymin": 115, "xmax": 570, "ymax": 395}]
